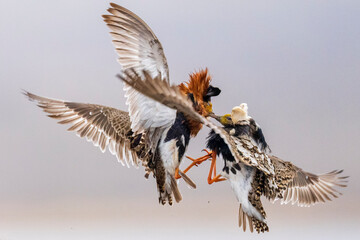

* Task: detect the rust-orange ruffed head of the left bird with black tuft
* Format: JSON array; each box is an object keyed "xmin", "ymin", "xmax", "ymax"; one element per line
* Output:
[{"xmin": 179, "ymin": 69, "xmax": 221, "ymax": 117}]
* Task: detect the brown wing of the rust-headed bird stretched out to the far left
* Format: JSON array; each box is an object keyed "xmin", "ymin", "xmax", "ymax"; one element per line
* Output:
[{"xmin": 24, "ymin": 91, "xmax": 145, "ymax": 166}]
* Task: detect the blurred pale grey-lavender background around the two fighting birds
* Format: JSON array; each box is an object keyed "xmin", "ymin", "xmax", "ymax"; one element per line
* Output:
[{"xmin": 0, "ymin": 0, "xmax": 360, "ymax": 240}]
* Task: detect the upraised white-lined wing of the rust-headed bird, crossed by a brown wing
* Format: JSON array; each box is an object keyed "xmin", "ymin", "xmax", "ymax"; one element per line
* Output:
[{"xmin": 103, "ymin": 3, "xmax": 176, "ymax": 139}]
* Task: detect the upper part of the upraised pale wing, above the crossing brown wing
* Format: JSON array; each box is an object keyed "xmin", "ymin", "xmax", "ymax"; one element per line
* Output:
[{"xmin": 103, "ymin": 3, "xmax": 169, "ymax": 81}]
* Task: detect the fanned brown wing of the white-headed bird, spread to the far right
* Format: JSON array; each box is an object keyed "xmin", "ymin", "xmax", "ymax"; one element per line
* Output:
[{"xmin": 271, "ymin": 156, "xmax": 348, "ymax": 206}]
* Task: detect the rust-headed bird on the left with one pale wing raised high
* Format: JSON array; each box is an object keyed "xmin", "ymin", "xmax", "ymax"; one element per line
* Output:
[{"xmin": 24, "ymin": 3, "xmax": 221, "ymax": 205}]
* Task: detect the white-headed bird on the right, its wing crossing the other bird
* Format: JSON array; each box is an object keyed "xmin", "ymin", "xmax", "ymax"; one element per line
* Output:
[{"xmin": 119, "ymin": 71, "xmax": 348, "ymax": 233}]
